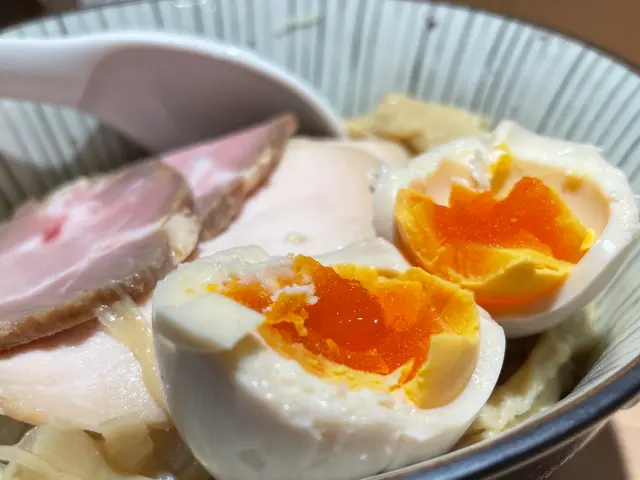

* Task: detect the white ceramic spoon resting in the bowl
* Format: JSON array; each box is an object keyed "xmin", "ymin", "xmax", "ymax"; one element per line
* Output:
[{"xmin": 0, "ymin": 32, "xmax": 343, "ymax": 152}]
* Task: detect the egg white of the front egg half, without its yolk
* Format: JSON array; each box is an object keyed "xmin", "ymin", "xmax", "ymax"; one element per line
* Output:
[{"xmin": 154, "ymin": 240, "xmax": 505, "ymax": 480}]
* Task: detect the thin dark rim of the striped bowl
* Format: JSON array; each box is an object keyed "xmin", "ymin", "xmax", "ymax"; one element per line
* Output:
[{"xmin": 0, "ymin": 0, "xmax": 640, "ymax": 480}]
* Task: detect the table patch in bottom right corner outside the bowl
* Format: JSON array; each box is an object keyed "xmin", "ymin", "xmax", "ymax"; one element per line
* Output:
[{"xmin": 550, "ymin": 404, "xmax": 640, "ymax": 480}]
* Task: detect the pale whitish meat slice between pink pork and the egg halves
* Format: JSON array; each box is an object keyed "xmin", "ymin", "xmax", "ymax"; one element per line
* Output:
[{"xmin": 198, "ymin": 138, "xmax": 409, "ymax": 255}]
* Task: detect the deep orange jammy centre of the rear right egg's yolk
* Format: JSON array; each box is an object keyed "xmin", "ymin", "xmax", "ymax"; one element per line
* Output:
[{"xmin": 433, "ymin": 177, "xmax": 586, "ymax": 264}]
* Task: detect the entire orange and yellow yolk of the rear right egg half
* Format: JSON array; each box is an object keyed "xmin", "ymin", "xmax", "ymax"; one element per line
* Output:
[{"xmin": 394, "ymin": 177, "xmax": 594, "ymax": 315}]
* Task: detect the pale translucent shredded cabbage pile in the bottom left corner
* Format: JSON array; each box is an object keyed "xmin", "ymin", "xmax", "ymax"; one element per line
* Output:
[{"xmin": 0, "ymin": 418, "xmax": 210, "ymax": 480}]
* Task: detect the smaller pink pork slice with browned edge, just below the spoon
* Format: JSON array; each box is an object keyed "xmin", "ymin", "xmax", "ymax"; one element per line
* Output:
[{"xmin": 162, "ymin": 115, "xmax": 298, "ymax": 240}]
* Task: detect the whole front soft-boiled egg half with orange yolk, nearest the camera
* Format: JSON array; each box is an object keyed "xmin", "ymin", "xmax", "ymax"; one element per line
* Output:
[{"xmin": 153, "ymin": 239, "xmax": 505, "ymax": 480}]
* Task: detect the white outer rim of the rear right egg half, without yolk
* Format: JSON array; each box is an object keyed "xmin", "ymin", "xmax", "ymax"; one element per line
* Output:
[{"xmin": 373, "ymin": 121, "xmax": 638, "ymax": 338}]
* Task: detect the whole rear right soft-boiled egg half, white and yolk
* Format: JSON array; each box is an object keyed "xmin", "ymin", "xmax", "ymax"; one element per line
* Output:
[{"xmin": 373, "ymin": 121, "xmax": 638, "ymax": 337}]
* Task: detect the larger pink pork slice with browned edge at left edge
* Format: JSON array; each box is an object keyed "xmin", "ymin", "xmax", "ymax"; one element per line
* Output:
[{"xmin": 0, "ymin": 162, "xmax": 199, "ymax": 350}]
